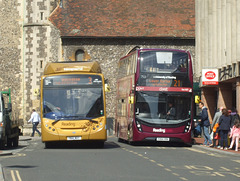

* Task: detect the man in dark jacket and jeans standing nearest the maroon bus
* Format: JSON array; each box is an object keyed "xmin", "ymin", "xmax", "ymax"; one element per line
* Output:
[{"xmin": 199, "ymin": 102, "xmax": 213, "ymax": 146}]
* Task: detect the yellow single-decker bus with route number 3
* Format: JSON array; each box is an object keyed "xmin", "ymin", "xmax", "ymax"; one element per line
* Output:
[{"xmin": 41, "ymin": 62, "xmax": 107, "ymax": 147}]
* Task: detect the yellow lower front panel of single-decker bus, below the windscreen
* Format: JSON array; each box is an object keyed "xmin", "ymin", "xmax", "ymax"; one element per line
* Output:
[{"xmin": 42, "ymin": 116, "xmax": 107, "ymax": 142}]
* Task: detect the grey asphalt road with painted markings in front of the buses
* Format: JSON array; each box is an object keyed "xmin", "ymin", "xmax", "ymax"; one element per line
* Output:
[{"xmin": 0, "ymin": 137, "xmax": 240, "ymax": 181}]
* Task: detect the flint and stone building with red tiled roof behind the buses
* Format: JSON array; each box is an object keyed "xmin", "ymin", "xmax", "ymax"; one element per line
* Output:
[{"xmin": 0, "ymin": 0, "xmax": 195, "ymax": 132}]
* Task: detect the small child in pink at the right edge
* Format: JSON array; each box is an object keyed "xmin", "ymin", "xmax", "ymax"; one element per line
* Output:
[{"xmin": 229, "ymin": 119, "xmax": 240, "ymax": 151}]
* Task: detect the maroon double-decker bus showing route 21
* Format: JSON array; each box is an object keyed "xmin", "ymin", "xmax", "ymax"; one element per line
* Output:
[{"xmin": 115, "ymin": 49, "xmax": 193, "ymax": 144}]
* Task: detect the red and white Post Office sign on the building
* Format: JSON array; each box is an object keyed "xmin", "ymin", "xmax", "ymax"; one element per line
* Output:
[{"xmin": 202, "ymin": 69, "xmax": 218, "ymax": 85}]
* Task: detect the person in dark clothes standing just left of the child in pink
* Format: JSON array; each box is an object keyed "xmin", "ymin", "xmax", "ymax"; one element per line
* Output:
[{"xmin": 219, "ymin": 108, "xmax": 231, "ymax": 150}]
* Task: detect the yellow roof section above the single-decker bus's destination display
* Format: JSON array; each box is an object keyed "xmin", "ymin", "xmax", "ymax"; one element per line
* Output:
[{"xmin": 44, "ymin": 61, "xmax": 101, "ymax": 75}]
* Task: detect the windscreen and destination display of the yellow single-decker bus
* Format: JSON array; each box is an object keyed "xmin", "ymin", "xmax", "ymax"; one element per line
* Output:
[{"xmin": 43, "ymin": 75, "xmax": 104, "ymax": 120}]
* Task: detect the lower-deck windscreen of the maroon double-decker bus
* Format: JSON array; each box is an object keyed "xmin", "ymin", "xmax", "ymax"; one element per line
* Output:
[{"xmin": 135, "ymin": 92, "xmax": 191, "ymax": 125}]
